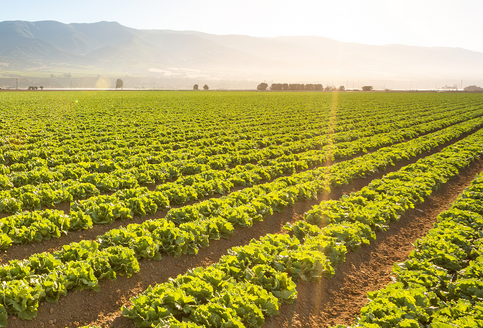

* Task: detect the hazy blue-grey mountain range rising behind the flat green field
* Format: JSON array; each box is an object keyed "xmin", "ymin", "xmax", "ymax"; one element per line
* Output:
[{"xmin": 0, "ymin": 21, "xmax": 483, "ymax": 86}]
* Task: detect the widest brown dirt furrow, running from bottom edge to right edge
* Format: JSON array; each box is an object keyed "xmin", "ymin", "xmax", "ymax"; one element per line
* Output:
[{"xmin": 265, "ymin": 155, "xmax": 483, "ymax": 328}]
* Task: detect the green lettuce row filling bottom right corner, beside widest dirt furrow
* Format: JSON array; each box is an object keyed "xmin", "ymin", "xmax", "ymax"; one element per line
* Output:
[{"xmin": 338, "ymin": 174, "xmax": 483, "ymax": 328}]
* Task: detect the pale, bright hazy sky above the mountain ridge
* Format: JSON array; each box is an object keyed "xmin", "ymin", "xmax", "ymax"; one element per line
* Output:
[{"xmin": 0, "ymin": 0, "xmax": 483, "ymax": 52}]
